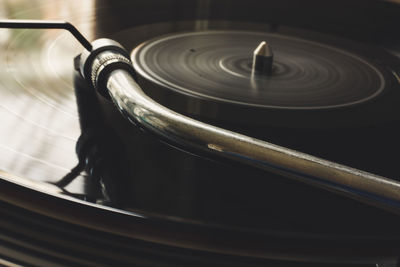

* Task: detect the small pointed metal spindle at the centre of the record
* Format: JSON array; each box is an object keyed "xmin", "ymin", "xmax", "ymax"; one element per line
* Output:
[{"xmin": 252, "ymin": 41, "xmax": 274, "ymax": 75}]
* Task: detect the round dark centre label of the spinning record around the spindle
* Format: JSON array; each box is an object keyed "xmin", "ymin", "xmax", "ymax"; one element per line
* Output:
[{"xmin": 132, "ymin": 31, "xmax": 385, "ymax": 109}]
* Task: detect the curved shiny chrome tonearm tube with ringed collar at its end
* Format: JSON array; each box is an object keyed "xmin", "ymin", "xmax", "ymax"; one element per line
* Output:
[{"xmin": 78, "ymin": 39, "xmax": 400, "ymax": 214}]
